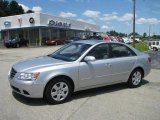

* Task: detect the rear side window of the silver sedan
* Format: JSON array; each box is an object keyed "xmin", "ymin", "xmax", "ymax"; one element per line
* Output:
[{"xmin": 110, "ymin": 43, "xmax": 136, "ymax": 58}]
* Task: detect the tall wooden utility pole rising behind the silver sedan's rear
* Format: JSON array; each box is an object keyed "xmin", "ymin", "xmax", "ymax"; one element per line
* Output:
[{"xmin": 133, "ymin": 0, "xmax": 136, "ymax": 47}]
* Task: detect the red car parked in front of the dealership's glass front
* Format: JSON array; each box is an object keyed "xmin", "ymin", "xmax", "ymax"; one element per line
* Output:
[{"xmin": 46, "ymin": 38, "xmax": 66, "ymax": 45}]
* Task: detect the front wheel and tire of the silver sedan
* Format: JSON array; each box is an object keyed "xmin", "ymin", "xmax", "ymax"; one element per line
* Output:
[{"xmin": 44, "ymin": 78, "xmax": 72, "ymax": 104}]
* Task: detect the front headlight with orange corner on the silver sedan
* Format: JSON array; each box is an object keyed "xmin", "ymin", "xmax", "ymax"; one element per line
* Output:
[{"xmin": 18, "ymin": 73, "xmax": 40, "ymax": 80}]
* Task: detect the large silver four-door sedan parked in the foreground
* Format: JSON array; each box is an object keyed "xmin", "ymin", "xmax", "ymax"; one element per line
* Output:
[{"xmin": 8, "ymin": 40, "xmax": 151, "ymax": 104}]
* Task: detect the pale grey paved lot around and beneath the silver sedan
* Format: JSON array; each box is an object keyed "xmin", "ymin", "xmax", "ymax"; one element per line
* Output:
[{"xmin": 0, "ymin": 46, "xmax": 160, "ymax": 120}]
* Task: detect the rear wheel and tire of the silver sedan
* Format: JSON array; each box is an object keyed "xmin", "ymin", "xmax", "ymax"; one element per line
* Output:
[{"xmin": 127, "ymin": 69, "xmax": 143, "ymax": 88}]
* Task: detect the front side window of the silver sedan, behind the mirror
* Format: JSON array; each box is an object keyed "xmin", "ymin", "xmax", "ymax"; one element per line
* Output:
[{"xmin": 87, "ymin": 44, "xmax": 109, "ymax": 60}]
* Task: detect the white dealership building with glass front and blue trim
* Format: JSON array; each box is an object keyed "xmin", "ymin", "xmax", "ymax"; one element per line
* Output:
[{"xmin": 0, "ymin": 13, "xmax": 100, "ymax": 46}]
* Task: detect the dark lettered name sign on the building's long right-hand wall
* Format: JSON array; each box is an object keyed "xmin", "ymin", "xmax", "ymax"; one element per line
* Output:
[{"xmin": 48, "ymin": 20, "xmax": 71, "ymax": 28}]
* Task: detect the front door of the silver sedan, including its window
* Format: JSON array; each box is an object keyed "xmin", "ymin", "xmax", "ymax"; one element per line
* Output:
[{"xmin": 79, "ymin": 44, "xmax": 111, "ymax": 88}]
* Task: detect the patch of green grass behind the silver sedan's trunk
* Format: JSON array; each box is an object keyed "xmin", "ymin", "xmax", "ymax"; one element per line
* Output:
[{"xmin": 130, "ymin": 41, "xmax": 149, "ymax": 52}]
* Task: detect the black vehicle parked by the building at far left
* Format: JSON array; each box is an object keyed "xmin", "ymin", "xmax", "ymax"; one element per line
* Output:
[{"xmin": 4, "ymin": 38, "xmax": 29, "ymax": 48}]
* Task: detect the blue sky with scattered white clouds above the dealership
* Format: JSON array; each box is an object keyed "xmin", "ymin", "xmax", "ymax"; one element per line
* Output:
[{"xmin": 16, "ymin": 0, "xmax": 160, "ymax": 35}]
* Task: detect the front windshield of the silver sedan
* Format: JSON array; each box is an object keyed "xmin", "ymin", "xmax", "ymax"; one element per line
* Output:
[{"xmin": 49, "ymin": 43, "xmax": 91, "ymax": 61}]
